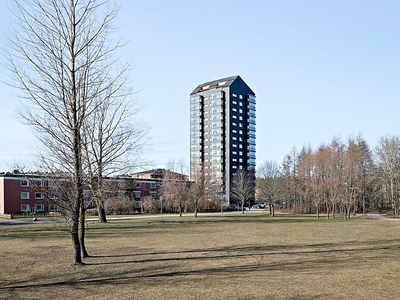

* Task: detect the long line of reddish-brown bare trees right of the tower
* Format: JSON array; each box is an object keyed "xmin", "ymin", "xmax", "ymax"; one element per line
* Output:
[{"xmin": 257, "ymin": 135, "xmax": 400, "ymax": 219}]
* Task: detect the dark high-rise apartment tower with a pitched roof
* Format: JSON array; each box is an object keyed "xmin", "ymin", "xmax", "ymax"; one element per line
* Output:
[{"xmin": 190, "ymin": 76, "xmax": 256, "ymax": 205}]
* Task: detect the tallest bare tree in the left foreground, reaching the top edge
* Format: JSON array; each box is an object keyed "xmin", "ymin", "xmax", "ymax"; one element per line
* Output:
[{"xmin": 7, "ymin": 0, "xmax": 130, "ymax": 264}]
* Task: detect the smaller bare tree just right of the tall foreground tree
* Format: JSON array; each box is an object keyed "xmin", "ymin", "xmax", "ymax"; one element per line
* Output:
[{"xmin": 84, "ymin": 89, "xmax": 148, "ymax": 222}]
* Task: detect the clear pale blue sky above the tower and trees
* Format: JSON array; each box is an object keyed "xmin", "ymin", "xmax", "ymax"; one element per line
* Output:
[{"xmin": 0, "ymin": 0, "xmax": 400, "ymax": 171}]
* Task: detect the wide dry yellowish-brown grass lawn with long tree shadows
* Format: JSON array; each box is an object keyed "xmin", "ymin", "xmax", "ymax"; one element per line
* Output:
[{"xmin": 0, "ymin": 214, "xmax": 400, "ymax": 300}]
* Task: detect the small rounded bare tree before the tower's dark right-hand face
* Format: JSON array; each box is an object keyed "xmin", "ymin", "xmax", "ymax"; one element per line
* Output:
[{"xmin": 230, "ymin": 170, "xmax": 254, "ymax": 214}]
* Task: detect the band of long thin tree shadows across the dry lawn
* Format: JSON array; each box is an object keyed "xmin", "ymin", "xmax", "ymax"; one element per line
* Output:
[{"xmin": 0, "ymin": 239, "xmax": 400, "ymax": 292}]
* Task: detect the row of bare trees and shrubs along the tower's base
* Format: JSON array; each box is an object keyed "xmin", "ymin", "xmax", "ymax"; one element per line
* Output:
[{"xmin": 155, "ymin": 160, "xmax": 254, "ymax": 217}]
